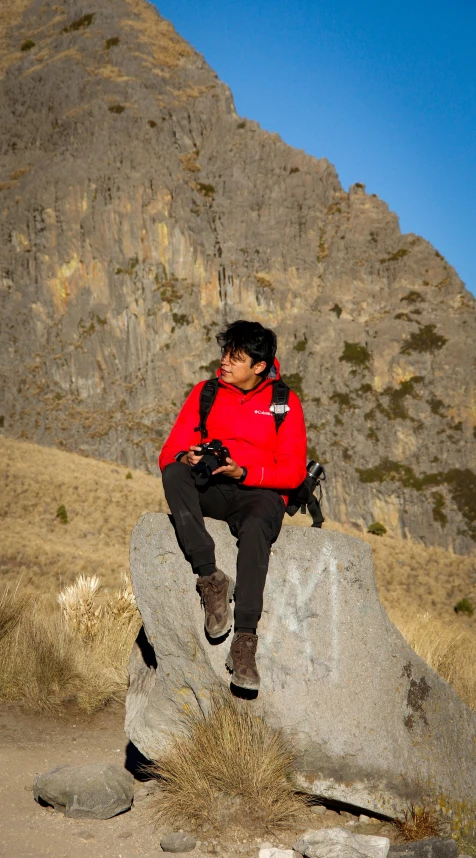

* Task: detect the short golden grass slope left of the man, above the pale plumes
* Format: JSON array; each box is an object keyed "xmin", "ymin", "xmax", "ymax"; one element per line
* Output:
[{"xmin": 0, "ymin": 436, "xmax": 166, "ymax": 596}]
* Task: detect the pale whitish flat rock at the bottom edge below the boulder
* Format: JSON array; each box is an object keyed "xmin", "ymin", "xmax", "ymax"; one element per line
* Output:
[{"xmin": 293, "ymin": 828, "xmax": 390, "ymax": 858}]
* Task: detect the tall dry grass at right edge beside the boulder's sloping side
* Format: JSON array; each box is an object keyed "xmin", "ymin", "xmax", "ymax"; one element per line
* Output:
[{"xmin": 389, "ymin": 609, "xmax": 476, "ymax": 710}]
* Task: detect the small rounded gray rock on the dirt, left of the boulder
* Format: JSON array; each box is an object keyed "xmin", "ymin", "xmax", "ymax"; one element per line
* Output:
[{"xmin": 33, "ymin": 763, "xmax": 134, "ymax": 819}]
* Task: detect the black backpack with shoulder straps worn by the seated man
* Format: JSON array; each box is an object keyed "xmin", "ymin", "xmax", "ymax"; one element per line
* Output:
[{"xmin": 195, "ymin": 378, "xmax": 326, "ymax": 527}]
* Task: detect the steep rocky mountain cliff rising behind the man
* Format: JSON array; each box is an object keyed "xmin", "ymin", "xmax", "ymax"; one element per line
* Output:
[{"xmin": 0, "ymin": 0, "xmax": 476, "ymax": 552}]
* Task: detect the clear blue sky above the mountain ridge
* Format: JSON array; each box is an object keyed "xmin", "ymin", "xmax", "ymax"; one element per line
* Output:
[{"xmin": 154, "ymin": 0, "xmax": 476, "ymax": 294}]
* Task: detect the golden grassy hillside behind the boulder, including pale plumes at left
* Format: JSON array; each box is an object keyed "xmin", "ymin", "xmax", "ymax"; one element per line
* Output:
[{"xmin": 0, "ymin": 436, "xmax": 476, "ymax": 712}]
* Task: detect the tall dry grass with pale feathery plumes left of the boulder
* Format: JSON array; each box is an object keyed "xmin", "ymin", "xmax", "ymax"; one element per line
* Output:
[{"xmin": 0, "ymin": 579, "xmax": 140, "ymax": 713}]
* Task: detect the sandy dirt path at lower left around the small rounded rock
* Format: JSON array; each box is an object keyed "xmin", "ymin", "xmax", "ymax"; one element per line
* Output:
[{"xmin": 0, "ymin": 705, "xmax": 161, "ymax": 858}]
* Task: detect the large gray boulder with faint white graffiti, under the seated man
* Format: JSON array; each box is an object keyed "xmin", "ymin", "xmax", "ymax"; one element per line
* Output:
[{"xmin": 126, "ymin": 513, "xmax": 476, "ymax": 816}]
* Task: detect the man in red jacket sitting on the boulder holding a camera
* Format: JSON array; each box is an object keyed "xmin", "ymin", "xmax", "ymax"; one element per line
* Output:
[{"xmin": 159, "ymin": 321, "xmax": 306, "ymax": 690}]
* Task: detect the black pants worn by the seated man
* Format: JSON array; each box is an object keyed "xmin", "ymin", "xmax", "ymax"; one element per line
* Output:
[{"xmin": 162, "ymin": 462, "xmax": 284, "ymax": 628}]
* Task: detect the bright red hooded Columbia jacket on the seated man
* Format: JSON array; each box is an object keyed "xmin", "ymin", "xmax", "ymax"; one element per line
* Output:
[{"xmin": 159, "ymin": 360, "xmax": 306, "ymax": 502}]
